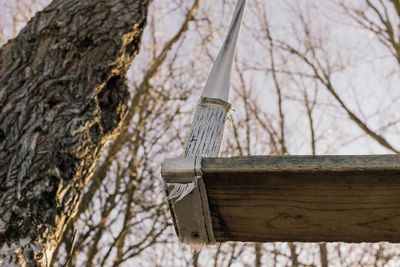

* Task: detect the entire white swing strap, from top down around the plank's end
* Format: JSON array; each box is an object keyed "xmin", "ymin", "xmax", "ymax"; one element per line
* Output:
[{"xmin": 162, "ymin": 0, "xmax": 246, "ymax": 250}]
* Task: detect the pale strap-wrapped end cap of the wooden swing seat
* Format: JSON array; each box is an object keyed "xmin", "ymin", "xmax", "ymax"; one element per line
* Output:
[{"xmin": 161, "ymin": 156, "xmax": 216, "ymax": 249}]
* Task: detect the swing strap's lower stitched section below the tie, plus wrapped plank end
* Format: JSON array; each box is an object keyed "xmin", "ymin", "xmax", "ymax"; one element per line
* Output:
[{"xmin": 162, "ymin": 98, "xmax": 231, "ymax": 250}]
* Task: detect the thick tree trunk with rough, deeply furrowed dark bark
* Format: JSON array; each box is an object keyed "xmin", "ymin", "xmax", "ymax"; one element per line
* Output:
[{"xmin": 0, "ymin": 0, "xmax": 151, "ymax": 266}]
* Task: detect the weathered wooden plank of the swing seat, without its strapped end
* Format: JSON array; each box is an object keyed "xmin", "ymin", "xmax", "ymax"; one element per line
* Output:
[{"xmin": 202, "ymin": 155, "xmax": 400, "ymax": 242}]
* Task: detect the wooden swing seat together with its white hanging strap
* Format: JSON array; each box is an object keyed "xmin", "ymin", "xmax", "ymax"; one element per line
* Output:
[{"xmin": 161, "ymin": 0, "xmax": 400, "ymax": 250}]
